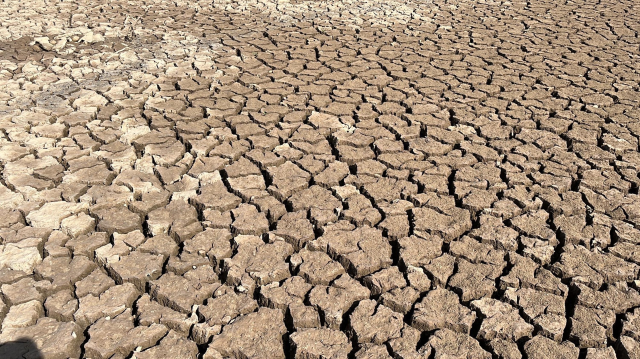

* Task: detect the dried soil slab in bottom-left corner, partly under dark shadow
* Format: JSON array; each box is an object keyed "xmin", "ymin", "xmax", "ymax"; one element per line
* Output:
[{"xmin": 0, "ymin": 318, "xmax": 84, "ymax": 359}]
